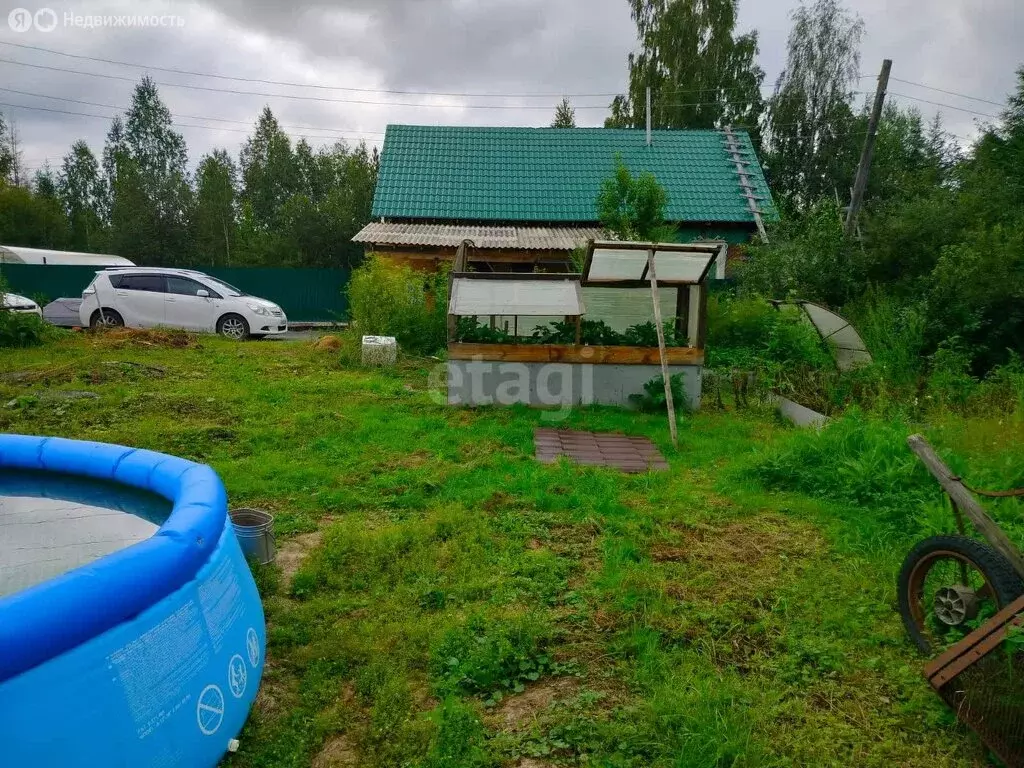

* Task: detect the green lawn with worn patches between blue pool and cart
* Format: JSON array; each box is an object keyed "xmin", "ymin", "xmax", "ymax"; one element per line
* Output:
[{"xmin": 0, "ymin": 337, "xmax": 1021, "ymax": 768}]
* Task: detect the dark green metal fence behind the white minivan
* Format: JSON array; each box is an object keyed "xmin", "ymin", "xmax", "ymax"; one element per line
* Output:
[{"xmin": 0, "ymin": 264, "xmax": 350, "ymax": 323}]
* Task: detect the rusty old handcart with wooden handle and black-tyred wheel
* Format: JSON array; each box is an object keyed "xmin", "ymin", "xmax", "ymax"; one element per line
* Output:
[{"xmin": 898, "ymin": 435, "xmax": 1024, "ymax": 766}]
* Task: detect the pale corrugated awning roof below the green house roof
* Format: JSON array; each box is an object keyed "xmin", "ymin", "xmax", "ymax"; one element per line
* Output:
[{"xmin": 352, "ymin": 221, "xmax": 602, "ymax": 251}]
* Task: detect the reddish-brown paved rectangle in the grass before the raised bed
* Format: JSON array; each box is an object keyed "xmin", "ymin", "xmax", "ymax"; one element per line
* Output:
[{"xmin": 534, "ymin": 429, "xmax": 669, "ymax": 473}]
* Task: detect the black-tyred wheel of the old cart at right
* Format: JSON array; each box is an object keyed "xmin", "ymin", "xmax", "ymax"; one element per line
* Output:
[{"xmin": 898, "ymin": 536, "xmax": 1024, "ymax": 654}]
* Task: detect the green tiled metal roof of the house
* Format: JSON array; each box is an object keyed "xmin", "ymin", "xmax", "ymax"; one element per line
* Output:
[{"xmin": 373, "ymin": 125, "xmax": 775, "ymax": 224}]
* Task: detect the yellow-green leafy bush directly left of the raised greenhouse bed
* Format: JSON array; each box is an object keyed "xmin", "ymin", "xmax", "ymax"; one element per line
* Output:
[{"xmin": 347, "ymin": 255, "xmax": 449, "ymax": 354}]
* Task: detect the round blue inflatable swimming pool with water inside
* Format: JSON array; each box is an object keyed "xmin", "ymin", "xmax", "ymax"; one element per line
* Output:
[{"xmin": 0, "ymin": 435, "xmax": 265, "ymax": 768}]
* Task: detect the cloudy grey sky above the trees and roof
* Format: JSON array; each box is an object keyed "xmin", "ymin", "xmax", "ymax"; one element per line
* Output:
[{"xmin": 0, "ymin": 0, "xmax": 1024, "ymax": 176}]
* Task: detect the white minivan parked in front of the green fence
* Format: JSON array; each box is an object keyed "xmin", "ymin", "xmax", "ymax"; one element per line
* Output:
[{"xmin": 79, "ymin": 266, "xmax": 288, "ymax": 339}]
